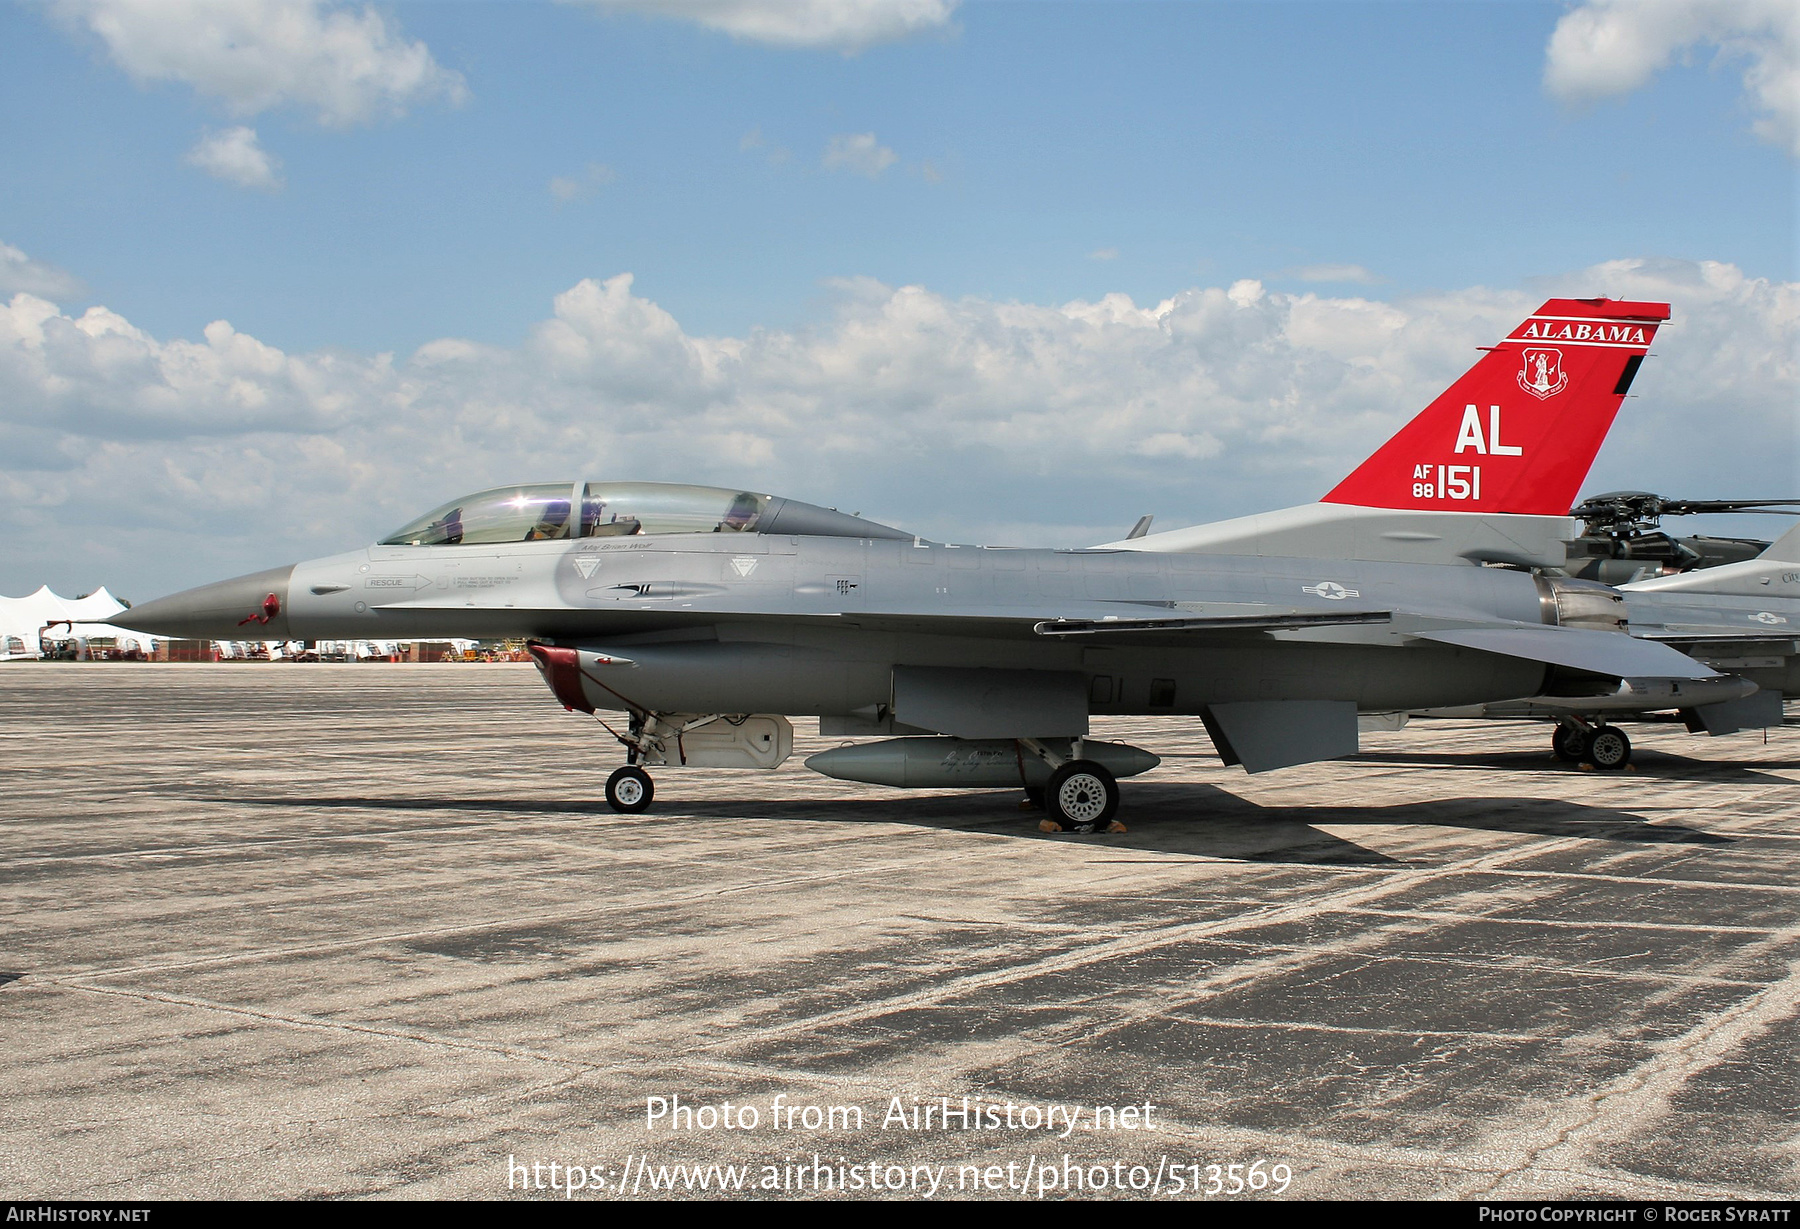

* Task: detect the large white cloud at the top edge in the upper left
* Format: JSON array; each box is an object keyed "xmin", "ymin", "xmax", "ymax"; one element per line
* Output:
[{"xmin": 52, "ymin": 0, "xmax": 466, "ymax": 128}]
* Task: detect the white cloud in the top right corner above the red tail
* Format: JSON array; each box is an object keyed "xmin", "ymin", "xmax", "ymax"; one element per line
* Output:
[{"xmin": 1544, "ymin": 0, "xmax": 1800, "ymax": 157}]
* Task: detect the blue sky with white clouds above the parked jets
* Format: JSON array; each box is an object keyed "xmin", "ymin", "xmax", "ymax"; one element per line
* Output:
[{"xmin": 0, "ymin": 0, "xmax": 1800, "ymax": 599}]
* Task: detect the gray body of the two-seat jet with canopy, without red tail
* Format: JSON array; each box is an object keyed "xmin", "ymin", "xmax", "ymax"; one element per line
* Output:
[{"xmin": 119, "ymin": 484, "xmax": 1715, "ymax": 819}]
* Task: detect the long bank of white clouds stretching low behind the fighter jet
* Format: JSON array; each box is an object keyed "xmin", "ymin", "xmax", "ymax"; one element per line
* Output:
[{"xmin": 0, "ymin": 241, "xmax": 1800, "ymax": 596}]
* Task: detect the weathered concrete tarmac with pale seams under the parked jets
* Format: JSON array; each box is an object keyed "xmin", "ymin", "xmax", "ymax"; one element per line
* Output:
[{"xmin": 0, "ymin": 664, "xmax": 1800, "ymax": 1198}]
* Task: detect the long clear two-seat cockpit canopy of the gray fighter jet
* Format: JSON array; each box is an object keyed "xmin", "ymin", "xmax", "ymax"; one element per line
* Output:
[{"xmin": 380, "ymin": 482, "xmax": 913, "ymax": 547}]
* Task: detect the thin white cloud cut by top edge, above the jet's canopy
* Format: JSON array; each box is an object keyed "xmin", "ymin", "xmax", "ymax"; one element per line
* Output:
[{"xmin": 585, "ymin": 0, "xmax": 958, "ymax": 54}]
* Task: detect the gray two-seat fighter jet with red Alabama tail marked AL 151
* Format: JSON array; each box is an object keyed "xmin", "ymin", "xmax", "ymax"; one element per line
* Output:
[{"xmin": 119, "ymin": 299, "xmax": 1717, "ymax": 831}]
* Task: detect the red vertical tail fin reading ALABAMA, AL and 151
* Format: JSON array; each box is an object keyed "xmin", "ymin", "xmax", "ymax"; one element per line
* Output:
[{"xmin": 1323, "ymin": 299, "xmax": 1669, "ymax": 516}]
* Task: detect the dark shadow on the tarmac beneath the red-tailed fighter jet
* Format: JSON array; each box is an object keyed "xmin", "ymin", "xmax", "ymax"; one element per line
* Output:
[{"xmin": 217, "ymin": 781, "xmax": 1732, "ymax": 866}]
